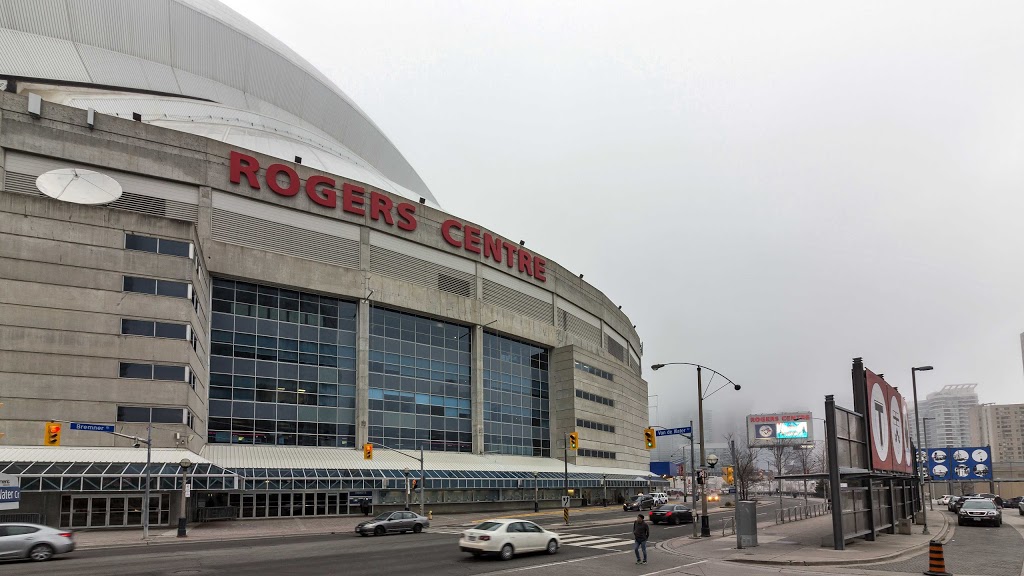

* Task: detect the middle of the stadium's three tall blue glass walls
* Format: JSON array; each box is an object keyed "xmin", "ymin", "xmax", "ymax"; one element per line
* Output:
[{"xmin": 369, "ymin": 307, "xmax": 473, "ymax": 452}]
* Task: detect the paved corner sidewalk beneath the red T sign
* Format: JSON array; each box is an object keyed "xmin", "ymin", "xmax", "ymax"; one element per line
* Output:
[{"xmin": 659, "ymin": 506, "xmax": 953, "ymax": 566}]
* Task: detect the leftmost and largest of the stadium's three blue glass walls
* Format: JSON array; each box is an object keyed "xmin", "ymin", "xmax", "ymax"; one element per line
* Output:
[{"xmin": 208, "ymin": 279, "xmax": 357, "ymax": 447}]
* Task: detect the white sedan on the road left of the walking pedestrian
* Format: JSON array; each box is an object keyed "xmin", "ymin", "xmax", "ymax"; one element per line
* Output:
[{"xmin": 459, "ymin": 518, "xmax": 561, "ymax": 560}]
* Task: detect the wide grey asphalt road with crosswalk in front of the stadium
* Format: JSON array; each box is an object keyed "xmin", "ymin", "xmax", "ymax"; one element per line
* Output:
[{"xmin": 6, "ymin": 496, "xmax": 806, "ymax": 576}]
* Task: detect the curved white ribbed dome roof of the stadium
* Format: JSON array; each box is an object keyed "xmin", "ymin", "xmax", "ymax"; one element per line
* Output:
[{"xmin": 0, "ymin": 0, "xmax": 438, "ymax": 207}]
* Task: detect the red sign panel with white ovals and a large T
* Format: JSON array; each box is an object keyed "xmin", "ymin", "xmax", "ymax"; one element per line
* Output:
[{"xmin": 864, "ymin": 370, "xmax": 913, "ymax": 475}]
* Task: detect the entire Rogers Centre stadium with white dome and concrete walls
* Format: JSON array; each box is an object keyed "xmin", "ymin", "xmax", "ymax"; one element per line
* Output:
[{"xmin": 0, "ymin": 0, "xmax": 666, "ymax": 528}]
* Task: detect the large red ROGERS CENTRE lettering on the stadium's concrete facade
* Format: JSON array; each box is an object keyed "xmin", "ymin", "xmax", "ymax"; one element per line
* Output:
[{"xmin": 230, "ymin": 151, "xmax": 548, "ymax": 282}]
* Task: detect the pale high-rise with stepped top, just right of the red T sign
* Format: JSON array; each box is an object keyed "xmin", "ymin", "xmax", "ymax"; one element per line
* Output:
[{"xmin": 909, "ymin": 384, "xmax": 978, "ymax": 448}]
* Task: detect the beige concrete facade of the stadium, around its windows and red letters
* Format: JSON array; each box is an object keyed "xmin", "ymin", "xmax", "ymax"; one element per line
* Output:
[{"xmin": 0, "ymin": 89, "xmax": 648, "ymax": 470}]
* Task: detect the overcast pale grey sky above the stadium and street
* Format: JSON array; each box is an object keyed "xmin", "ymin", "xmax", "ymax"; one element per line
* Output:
[{"xmin": 227, "ymin": 0, "xmax": 1024, "ymax": 425}]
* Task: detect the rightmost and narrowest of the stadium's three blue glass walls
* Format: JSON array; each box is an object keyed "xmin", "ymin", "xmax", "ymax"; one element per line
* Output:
[{"xmin": 483, "ymin": 332, "xmax": 551, "ymax": 457}]
